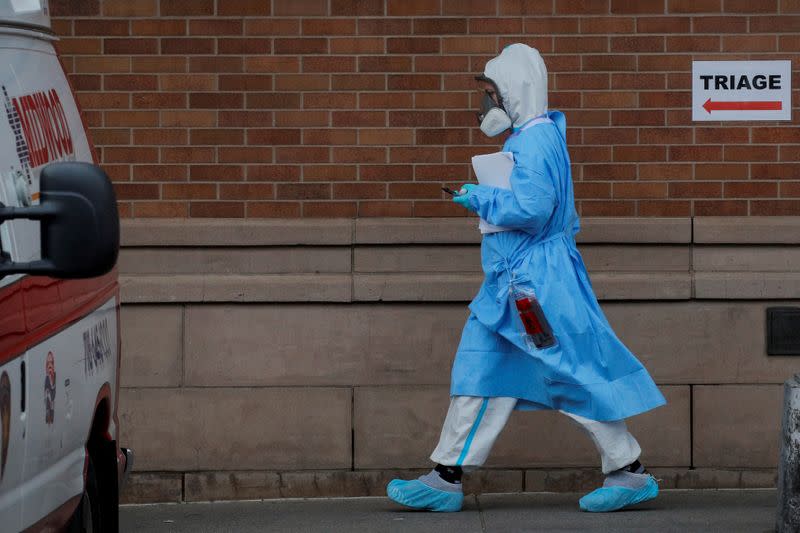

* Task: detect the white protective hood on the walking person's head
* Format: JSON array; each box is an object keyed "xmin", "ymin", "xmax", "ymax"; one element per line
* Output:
[{"xmin": 483, "ymin": 43, "xmax": 547, "ymax": 128}]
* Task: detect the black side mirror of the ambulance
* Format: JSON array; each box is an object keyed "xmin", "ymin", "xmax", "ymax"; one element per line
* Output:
[{"xmin": 0, "ymin": 162, "xmax": 119, "ymax": 279}]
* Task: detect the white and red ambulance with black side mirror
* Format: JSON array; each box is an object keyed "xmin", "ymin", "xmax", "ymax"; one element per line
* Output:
[{"xmin": 0, "ymin": 0, "xmax": 132, "ymax": 532}]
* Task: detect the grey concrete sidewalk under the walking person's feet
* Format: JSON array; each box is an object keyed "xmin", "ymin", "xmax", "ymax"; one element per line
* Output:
[{"xmin": 120, "ymin": 490, "xmax": 776, "ymax": 533}]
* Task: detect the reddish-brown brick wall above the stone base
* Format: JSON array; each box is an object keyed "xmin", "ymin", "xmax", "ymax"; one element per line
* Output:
[{"xmin": 51, "ymin": 0, "xmax": 800, "ymax": 218}]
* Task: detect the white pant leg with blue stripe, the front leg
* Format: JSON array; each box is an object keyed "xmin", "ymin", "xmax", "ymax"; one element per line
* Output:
[{"xmin": 431, "ymin": 396, "xmax": 517, "ymax": 470}]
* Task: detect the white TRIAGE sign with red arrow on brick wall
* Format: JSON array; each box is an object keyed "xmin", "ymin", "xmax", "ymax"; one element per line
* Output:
[{"xmin": 692, "ymin": 61, "xmax": 792, "ymax": 121}]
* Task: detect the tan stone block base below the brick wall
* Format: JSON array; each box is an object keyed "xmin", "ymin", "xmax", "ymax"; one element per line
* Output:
[{"xmin": 119, "ymin": 217, "xmax": 800, "ymax": 502}]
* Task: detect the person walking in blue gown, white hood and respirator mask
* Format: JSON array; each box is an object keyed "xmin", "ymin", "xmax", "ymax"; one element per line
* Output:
[{"xmin": 387, "ymin": 44, "xmax": 666, "ymax": 512}]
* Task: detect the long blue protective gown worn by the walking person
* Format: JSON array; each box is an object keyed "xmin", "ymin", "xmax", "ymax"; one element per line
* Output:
[{"xmin": 451, "ymin": 111, "xmax": 666, "ymax": 421}]
